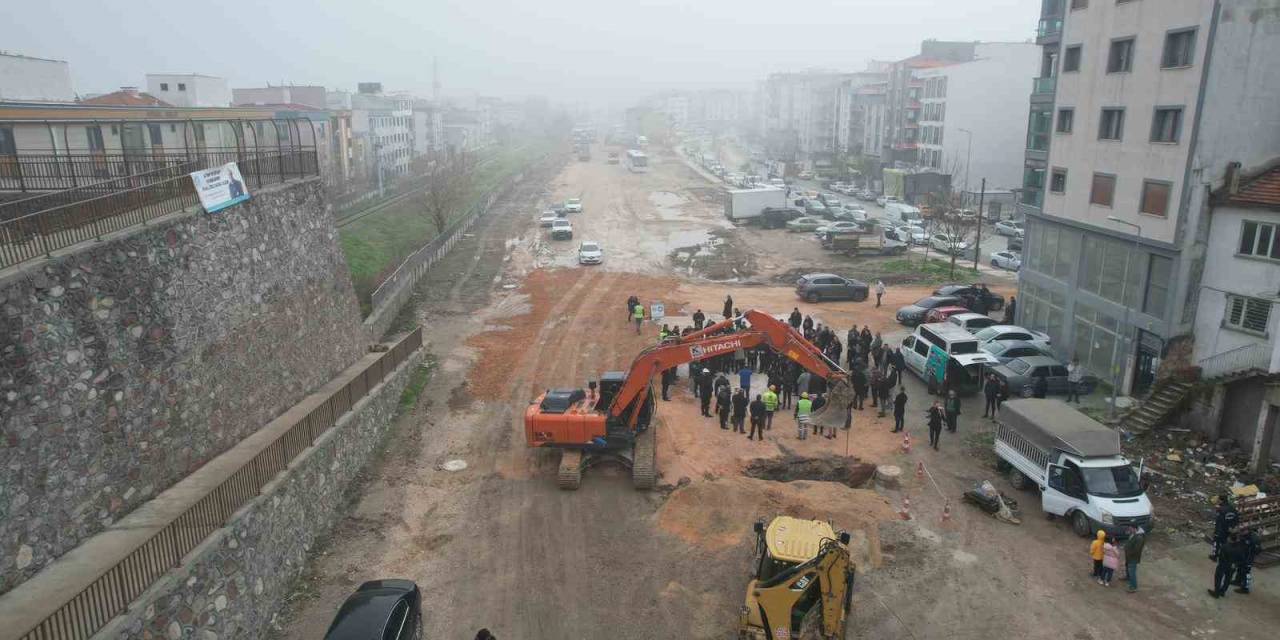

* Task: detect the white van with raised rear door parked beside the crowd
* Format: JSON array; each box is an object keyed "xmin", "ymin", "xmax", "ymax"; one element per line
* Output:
[{"xmin": 902, "ymin": 323, "xmax": 1000, "ymax": 396}]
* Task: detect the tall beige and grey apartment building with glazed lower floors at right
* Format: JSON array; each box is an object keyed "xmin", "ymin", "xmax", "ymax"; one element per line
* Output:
[{"xmin": 1018, "ymin": 0, "xmax": 1280, "ymax": 404}]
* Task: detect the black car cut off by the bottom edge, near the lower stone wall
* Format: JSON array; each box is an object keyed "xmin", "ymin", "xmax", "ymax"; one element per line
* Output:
[{"xmin": 324, "ymin": 579, "xmax": 422, "ymax": 640}]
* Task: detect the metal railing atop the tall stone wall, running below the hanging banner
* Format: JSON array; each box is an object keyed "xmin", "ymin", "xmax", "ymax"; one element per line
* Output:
[{"xmin": 0, "ymin": 147, "xmax": 320, "ymax": 269}]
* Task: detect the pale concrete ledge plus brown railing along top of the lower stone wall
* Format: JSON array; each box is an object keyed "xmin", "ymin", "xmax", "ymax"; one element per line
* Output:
[{"xmin": 0, "ymin": 326, "xmax": 422, "ymax": 640}]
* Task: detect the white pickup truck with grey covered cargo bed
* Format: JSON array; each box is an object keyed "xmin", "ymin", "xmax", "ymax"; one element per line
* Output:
[{"xmin": 996, "ymin": 398, "xmax": 1155, "ymax": 538}]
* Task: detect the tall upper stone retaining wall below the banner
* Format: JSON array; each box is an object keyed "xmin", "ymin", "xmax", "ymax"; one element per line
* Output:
[{"xmin": 0, "ymin": 179, "xmax": 365, "ymax": 593}]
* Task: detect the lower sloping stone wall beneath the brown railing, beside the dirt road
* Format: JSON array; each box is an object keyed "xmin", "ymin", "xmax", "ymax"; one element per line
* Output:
[{"xmin": 93, "ymin": 349, "xmax": 424, "ymax": 640}]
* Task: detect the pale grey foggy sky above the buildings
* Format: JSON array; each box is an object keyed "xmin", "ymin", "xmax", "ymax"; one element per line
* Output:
[{"xmin": 0, "ymin": 0, "xmax": 1039, "ymax": 102}]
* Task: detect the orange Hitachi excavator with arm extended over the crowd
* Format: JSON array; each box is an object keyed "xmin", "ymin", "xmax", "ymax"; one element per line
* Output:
[{"xmin": 525, "ymin": 310, "xmax": 851, "ymax": 490}]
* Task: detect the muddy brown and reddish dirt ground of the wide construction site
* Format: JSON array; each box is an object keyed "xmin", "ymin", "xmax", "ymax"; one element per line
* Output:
[{"xmin": 278, "ymin": 146, "xmax": 1280, "ymax": 640}]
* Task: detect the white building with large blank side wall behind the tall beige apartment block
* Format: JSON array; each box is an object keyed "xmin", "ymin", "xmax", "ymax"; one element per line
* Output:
[{"xmin": 915, "ymin": 42, "xmax": 1041, "ymax": 191}]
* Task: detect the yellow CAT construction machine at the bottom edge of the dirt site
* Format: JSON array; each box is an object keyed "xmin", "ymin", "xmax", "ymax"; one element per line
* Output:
[{"xmin": 739, "ymin": 516, "xmax": 854, "ymax": 640}]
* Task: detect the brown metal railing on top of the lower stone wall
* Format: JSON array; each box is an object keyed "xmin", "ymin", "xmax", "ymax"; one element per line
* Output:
[{"xmin": 19, "ymin": 326, "xmax": 422, "ymax": 640}]
